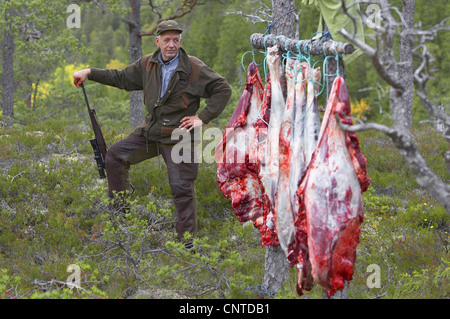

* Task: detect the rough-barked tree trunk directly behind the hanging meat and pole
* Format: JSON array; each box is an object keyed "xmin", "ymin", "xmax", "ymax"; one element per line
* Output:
[{"xmin": 263, "ymin": 0, "xmax": 295, "ymax": 292}]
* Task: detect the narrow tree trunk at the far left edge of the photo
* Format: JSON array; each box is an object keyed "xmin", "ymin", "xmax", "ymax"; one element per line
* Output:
[{"xmin": 1, "ymin": 0, "xmax": 15, "ymax": 126}]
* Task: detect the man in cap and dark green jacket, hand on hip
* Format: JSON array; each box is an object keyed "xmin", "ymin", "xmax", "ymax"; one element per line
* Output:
[{"xmin": 74, "ymin": 20, "xmax": 231, "ymax": 248}]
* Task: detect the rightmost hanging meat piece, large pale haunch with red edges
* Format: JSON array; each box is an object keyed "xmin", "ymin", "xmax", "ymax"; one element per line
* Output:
[{"xmin": 295, "ymin": 76, "xmax": 370, "ymax": 297}]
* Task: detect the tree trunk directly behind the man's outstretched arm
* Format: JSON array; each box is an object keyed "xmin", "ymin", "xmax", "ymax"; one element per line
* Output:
[{"xmin": 129, "ymin": 0, "xmax": 143, "ymax": 126}]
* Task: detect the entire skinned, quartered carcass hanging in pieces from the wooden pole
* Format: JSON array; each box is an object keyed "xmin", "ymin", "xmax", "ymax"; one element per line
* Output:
[{"xmin": 216, "ymin": 46, "xmax": 370, "ymax": 296}]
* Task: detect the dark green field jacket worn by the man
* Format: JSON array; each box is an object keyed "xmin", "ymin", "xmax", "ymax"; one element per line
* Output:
[{"xmin": 88, "ymin": 48, "xmax": 231, "ymax": 144}]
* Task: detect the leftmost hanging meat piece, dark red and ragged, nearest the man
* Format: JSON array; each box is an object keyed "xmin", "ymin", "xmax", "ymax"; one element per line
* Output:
[{"xmin": 215, "ymin": 62, "xmax": 270, "ymax": 239}]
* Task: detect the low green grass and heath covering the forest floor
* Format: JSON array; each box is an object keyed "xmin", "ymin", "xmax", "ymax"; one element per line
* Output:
[{"xmin": 0, "ymin": 120, "xmax": 450, "ymax": 299}]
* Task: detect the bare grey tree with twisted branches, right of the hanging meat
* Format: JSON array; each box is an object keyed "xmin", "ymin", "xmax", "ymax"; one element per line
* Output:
[{"xmin": 340, "ymin": 0, "xmax": 450, "ymax": 213}]
